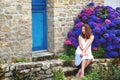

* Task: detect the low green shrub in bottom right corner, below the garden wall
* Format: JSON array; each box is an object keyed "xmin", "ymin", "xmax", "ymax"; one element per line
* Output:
[{"xmin": 82, "ymin": 63, "xmax": 120, "ymax": 80}]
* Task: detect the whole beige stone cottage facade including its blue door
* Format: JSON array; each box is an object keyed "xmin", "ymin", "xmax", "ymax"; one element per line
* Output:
[{"xmin": 0, "ymin": 0, "xmax": 120, "ymax": 63}]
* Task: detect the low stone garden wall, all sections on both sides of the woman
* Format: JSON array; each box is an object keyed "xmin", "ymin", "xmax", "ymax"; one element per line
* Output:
[{"xmin": 0, "ymin": 58, "xmax": 120, "ymax": 80}]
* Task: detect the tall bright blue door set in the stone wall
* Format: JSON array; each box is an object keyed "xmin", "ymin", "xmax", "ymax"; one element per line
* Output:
[{"xmin": 32, "ymin": 0, "xmax": 47, "ymax": 51}]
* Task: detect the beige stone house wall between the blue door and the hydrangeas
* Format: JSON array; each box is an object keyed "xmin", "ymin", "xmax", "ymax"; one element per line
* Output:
[{"xmin": 47, "ymin": 0, "xmax": 104, "ymax": 53}]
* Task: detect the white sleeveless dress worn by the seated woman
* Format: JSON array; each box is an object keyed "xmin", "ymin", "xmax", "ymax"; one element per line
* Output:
[{"xmin": 75, "ymin": 36, "xmax": 94, "ymax": 66}]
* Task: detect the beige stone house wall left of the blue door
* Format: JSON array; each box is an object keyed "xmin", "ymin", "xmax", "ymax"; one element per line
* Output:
[{"xmin": 0, "ymin": 0, "xmax": 32, "ymax": 63}]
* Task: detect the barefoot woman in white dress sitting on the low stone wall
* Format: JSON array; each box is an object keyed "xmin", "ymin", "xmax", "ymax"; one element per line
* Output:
[{"xmin": 75, "ymin": 24, "xmax": 94, "ymax": 77}]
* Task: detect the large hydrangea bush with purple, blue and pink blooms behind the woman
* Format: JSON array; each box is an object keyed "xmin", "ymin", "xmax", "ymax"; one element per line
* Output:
[{"xmin": 65, "ymin": 2, "xmax": 120, "ymax": 58}]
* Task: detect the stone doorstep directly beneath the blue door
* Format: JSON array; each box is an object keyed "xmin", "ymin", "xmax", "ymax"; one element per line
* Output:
[{"xmin": 32, "ymin": 51, "xmax": 56, "ymax": 62}]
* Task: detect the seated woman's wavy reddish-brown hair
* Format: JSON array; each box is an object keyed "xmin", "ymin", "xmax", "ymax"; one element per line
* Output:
[{"xmin": 81, "ymin": 24, "xmax": 92, "ymax": 39}]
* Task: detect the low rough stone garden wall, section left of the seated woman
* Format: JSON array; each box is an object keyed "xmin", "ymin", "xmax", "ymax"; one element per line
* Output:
[{"xmin": 0, "ymin": 60, "xmax": 63, "ymax": 80}]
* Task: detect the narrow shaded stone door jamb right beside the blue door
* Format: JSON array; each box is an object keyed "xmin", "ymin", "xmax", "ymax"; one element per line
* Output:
[{"xmin": 47, "ymin": 0, "xmax": 54, "ymax": 52}]
